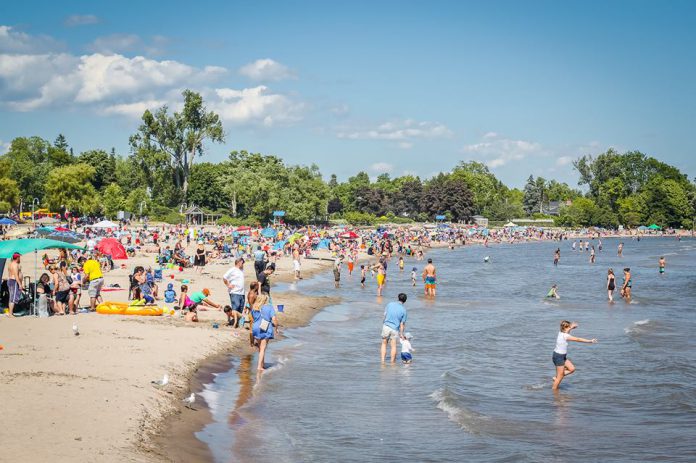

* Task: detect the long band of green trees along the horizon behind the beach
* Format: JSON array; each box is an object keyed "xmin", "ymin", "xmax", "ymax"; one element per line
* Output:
[{"xmin": 0, "ymin": 91, "xmax": 696, "ymax": 227}]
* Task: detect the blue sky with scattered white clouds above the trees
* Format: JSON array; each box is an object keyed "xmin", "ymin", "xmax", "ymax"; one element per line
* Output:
[{"xmin": 0, "ymin": 0, "xmax": 696, "ymax": 187}]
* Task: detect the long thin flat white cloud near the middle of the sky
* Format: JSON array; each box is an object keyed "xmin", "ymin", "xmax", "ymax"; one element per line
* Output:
[{"xmin": 337, "ymin": 119, "xmax": 452, "ymax": 141}]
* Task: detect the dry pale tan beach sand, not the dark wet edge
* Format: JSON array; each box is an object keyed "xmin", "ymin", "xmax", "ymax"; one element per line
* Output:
[{"xmin": 0, "ymin": 243, "xmax": 336, "ymax": 462}]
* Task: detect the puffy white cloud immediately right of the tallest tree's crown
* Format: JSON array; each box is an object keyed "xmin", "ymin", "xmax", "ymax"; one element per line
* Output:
[{"xmin": 210, "ymin": 85, "xmax": 304, "ymax": 127}]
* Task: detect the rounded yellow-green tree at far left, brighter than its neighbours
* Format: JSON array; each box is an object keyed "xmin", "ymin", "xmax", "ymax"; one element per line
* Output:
[{"xmin": 45, "ymin": 164, "xmax": 101, "ymax": 214}]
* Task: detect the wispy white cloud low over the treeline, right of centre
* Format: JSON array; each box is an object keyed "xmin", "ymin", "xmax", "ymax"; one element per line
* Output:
[{"xmin": 462, "ymin": 132, "xmax": 546, "ymax": 168}]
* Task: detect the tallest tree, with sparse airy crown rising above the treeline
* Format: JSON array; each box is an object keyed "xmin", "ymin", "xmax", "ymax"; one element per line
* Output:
[{"xmin": 130, "ymin": 90, "xmax": 225, "ymax": 197}]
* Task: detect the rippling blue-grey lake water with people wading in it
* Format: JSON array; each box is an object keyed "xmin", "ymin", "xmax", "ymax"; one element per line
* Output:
[{"xmin": 197, "ymin": 238, "xmax": 696, "ymax": 462}]
